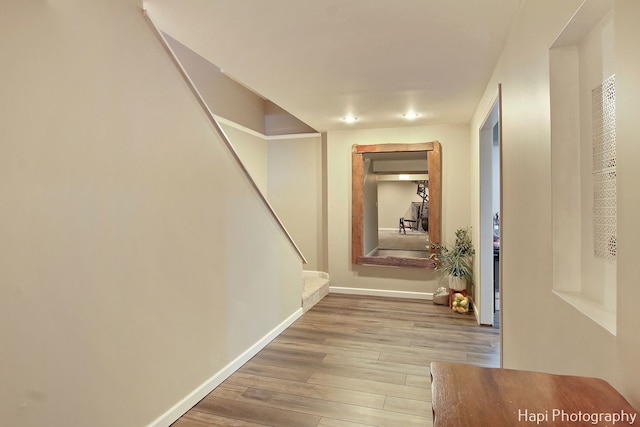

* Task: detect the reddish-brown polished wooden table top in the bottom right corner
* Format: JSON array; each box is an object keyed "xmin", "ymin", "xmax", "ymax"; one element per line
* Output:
[{"xmin": 431, "ymin": 362, "xmax": 640, "ymax": 427}]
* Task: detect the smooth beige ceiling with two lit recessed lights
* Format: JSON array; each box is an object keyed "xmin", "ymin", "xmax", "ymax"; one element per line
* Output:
[{"xmin": 143, "ymin": 0, "xmax": 523, "ymax": 132}]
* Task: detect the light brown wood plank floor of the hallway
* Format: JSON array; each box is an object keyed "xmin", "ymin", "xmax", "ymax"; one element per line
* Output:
[{"xmin": 173, "ymin": 294, "xmax": 499, "ymax": 427}]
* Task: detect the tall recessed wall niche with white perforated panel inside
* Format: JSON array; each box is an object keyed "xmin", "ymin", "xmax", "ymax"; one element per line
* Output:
[{"xmin": 549, "ymin": 0, "xmax": 617, "ymax": 335}]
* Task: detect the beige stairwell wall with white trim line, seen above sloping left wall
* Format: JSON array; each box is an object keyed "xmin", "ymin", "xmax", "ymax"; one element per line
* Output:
[{"xmin": 162, "ymin": 27, "xmax": 327, "ymax": 271}]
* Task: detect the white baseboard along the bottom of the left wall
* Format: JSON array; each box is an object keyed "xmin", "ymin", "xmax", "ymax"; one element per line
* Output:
[{"xmin": 147, "ymin": 308, "xmax": 302, "ymax": 427}]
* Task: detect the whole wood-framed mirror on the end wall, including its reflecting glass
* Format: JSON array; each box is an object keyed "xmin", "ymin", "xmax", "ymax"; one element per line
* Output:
[{"xmin": 352, "ymin": 141, "xmax": 441, "ymax": 267}]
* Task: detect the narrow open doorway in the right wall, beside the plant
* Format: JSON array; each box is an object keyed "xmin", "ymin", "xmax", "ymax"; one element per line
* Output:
[{"xmin": 478, "ymin": 86, "xmax": 502, "ymax": 326}]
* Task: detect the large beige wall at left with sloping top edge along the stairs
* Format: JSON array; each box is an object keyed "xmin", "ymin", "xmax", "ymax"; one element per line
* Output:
[{"xmin": 0, "ymin": 0, "xmax": 302, "ymax": 427}]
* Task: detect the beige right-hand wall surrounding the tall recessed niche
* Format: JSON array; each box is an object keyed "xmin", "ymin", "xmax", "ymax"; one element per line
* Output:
[{"xmin": 471, "ymin": 0, "xmax": 640, "ymax": 407}]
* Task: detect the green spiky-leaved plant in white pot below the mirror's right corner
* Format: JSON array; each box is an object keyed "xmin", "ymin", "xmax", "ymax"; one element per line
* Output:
[{"xmin": 430, "ymin": 228, "xmax": 475, "ymax": 291}]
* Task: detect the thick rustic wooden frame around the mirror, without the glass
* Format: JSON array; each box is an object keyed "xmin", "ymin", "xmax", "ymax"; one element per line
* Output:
[{"xmin": 351, "ymin": 141, "xmax": 442, "ymax": 268}]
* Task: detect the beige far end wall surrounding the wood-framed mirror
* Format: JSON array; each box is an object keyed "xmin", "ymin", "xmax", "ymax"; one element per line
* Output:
[{"xmin": 326, "ymin": 125, "xmax": 471, "ymax": 293}]
